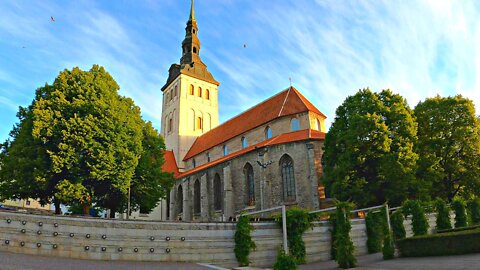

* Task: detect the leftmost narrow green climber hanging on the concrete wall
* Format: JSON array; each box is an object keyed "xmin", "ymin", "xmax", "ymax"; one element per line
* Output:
[{"xmin": 234, "ymin": 216, "xmax": 255, "ymax": 266}]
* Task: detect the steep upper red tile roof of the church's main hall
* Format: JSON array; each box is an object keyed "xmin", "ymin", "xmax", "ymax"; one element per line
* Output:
[{"xmin": 183, "ymin": 87, "xmax": 326, "ymax": 161}]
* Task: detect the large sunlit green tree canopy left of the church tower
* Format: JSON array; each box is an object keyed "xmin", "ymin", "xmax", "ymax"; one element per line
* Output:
[{"xmin": 0, "ymin": 65, "xmax": 173, "ymax": 215}]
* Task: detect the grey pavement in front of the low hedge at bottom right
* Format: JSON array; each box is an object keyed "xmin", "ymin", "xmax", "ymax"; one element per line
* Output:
[{"xmin": 300, "ymin": 253, "xmax": 480, "ymax": 270}]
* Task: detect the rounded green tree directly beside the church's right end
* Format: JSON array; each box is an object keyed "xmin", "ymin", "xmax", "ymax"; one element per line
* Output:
[{"xmin": 324, "ymin": 89, "xmax": 424, "ymax": 207}]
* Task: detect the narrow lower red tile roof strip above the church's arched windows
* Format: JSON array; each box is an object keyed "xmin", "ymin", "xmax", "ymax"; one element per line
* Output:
[{"xmin": 176, "ymin": 129, "xmax": 325, "ymax": 179}]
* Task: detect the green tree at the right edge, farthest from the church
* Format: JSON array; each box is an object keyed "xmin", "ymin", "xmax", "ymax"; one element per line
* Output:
[{"xmin": 415, "ymin": 96, "xmax": 480, "ymax": 202}]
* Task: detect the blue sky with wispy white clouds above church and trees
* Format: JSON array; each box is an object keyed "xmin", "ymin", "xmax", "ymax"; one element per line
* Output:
[{"xmin": 0, "ymin": 0, "xmax": 480, "ymax": 141}]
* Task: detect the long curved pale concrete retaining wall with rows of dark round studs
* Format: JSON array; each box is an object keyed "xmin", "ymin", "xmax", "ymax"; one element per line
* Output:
[{"xmin": 0, "ymin": 211, "xmax": 438, "ymax": 267}]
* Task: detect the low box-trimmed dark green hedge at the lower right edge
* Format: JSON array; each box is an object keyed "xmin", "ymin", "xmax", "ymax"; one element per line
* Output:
[{"xmin": 397, "ymin": 230, "xmax": 480, "ymax": 257}]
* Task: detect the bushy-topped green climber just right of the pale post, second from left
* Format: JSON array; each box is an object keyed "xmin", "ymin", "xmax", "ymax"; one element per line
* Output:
[{"xmin": 278, "ymin": 208, "xmax": 314, "ymax": 264}]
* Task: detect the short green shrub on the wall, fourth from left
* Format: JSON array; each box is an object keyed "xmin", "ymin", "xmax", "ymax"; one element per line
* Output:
[{"xmin": 365, "ymin": 210, "xmax": 385, "ymax": 253}]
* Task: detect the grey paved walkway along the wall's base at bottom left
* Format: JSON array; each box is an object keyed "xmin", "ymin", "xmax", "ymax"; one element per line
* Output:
[{"xmin": 0, "ymin": 252, "xmax": 214, "ymax": 270}]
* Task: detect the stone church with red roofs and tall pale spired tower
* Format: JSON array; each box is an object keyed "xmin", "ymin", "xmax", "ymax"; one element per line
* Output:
[{"xmin": 160, "ymin": 0, "xmax": 326, "ymax": 221}]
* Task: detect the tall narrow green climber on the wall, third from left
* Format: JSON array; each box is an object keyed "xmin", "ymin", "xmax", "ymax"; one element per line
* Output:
[{"xmin": 335, "ymin": 202, "xmax": 357, "ymax": 269}]
